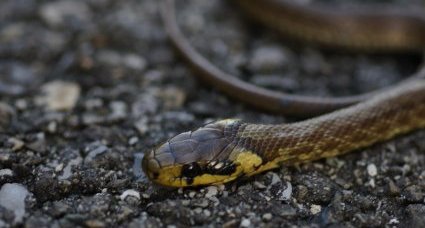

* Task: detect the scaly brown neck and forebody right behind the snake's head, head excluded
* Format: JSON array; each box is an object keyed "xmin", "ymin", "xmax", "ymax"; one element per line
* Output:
[{"xmin": 233, "ymin": 80, "xmax": 425, "ymax": 167}]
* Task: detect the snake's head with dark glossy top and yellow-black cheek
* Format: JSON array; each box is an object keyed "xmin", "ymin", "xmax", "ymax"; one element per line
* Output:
[{"xmin": 142, "ymin": 119, "xmax": 241, "ymax": 187}]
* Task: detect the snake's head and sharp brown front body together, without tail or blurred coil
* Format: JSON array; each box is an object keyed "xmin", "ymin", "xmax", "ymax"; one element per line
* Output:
[{"xmin": 143, "ymin": 76, "xmax": 425, "ymax": 187}]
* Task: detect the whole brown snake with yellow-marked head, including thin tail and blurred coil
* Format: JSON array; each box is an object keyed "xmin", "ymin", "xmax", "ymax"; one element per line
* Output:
[{"xmin": 142, "ymin": 0, "xmax": 425, "ymax": 187}]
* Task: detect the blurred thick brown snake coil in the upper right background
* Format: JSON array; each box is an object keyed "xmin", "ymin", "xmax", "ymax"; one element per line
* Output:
[{"xmin": 232, "ymin": 0, "xmax": 425, "ymax": 50}]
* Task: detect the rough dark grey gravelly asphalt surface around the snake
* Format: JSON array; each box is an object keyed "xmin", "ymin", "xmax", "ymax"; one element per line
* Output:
[{"xmin": 0, "ymin": 0, "xmax": 425, "ymax": 227}]
